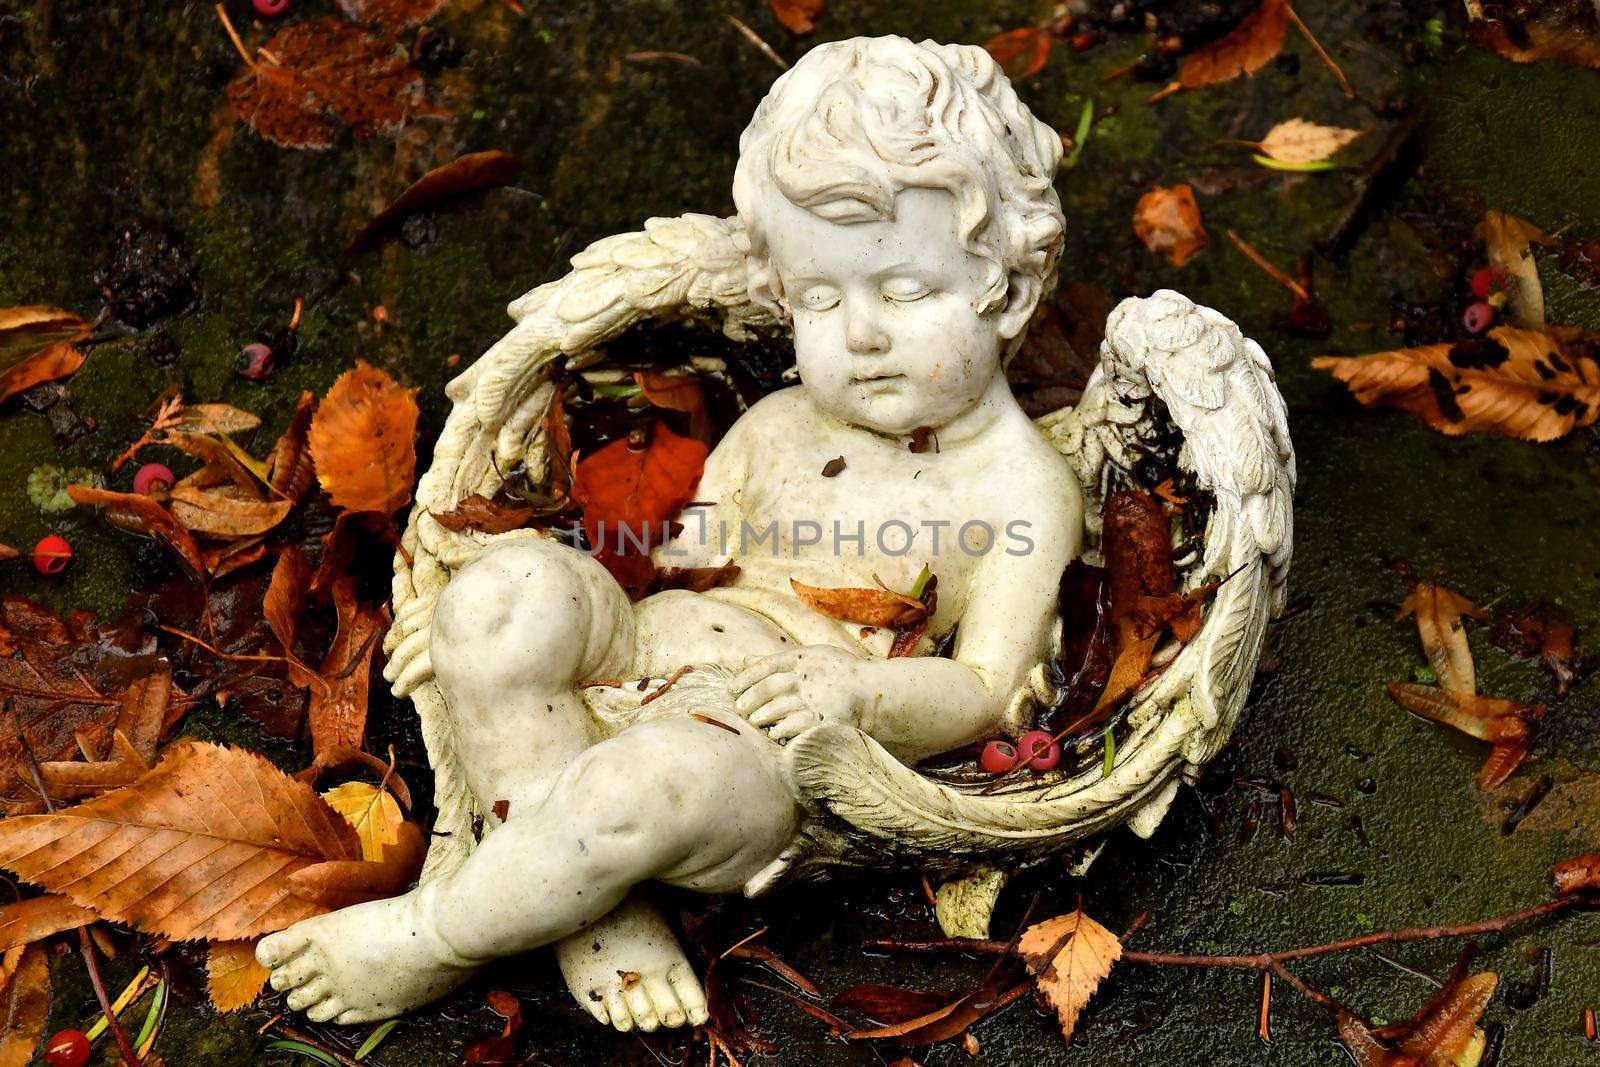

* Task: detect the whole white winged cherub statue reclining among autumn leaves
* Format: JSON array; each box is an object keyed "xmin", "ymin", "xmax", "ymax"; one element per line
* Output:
[{"xmin": 258, "ymin": 37, "xmax": 1293, "ymax": 1030}]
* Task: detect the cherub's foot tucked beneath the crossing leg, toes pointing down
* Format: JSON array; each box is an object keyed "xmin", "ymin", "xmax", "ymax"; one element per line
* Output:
[{"xmin": 555, "ymin": 901, "xmax": 709, "ymax": 1033}]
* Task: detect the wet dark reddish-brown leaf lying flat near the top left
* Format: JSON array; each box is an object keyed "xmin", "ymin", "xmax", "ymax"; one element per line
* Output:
[{"xmin": 227, "ymin": 16, "xmax": 450, "ymax": 149}]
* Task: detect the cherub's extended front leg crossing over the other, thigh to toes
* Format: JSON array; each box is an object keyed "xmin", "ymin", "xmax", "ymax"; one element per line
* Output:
[{"xmin": 258, "ymin": 715, "xmax": 798, "ymax": 1022}]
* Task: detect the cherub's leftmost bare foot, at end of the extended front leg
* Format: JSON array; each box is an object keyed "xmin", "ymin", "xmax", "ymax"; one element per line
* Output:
[{"xmin": 256, "ymin": 891, "xmax": 475, "ymax": 1024}]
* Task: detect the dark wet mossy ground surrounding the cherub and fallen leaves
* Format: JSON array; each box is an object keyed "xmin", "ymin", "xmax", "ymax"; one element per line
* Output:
[{"xmin": 0, "ymin": 0, "xmax": 1600, "ymax": 1067}]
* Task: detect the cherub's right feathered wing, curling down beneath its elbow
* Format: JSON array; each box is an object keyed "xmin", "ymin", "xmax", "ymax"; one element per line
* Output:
[{"xmin": 766, "ymin": 290, "xmax": 1294, "ymax": 881}]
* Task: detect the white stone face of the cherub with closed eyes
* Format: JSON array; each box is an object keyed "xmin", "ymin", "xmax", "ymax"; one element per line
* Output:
[{"xmin": 762, "ymin": 189, "xmax": 1006, "ymax": 434}]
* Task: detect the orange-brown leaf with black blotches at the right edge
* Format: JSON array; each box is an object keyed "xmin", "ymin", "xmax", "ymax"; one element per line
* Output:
[{"xmin": 1310, "ymin": 326, "xmax": 1600, "ymax": 442}]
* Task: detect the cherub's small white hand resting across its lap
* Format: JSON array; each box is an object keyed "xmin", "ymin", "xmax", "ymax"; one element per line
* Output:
[{"xmin": 733, "ymin": 645, "xmax": 867, "ymax": 741}]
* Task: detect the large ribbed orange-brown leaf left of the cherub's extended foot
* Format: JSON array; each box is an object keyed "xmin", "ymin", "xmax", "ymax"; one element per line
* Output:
[{"xmin": 0, "ymin": 742, "xmax": 360, "ymax": 941}]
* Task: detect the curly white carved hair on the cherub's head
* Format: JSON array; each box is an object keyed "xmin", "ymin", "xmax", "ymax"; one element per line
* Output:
[{"xmin": 733, "ymin": 37, "xmax": 1066, "ymax": 317}]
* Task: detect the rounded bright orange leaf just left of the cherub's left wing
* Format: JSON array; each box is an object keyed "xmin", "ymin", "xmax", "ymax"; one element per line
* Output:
[{"xmin": 307, "ymin": 362, "xmax": 418, "ymax": 515}]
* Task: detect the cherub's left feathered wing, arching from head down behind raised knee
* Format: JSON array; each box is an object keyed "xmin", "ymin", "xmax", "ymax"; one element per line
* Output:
[{"xmin": 384, "ymin": 214, "xmax": 773, "ymax": 880}]
